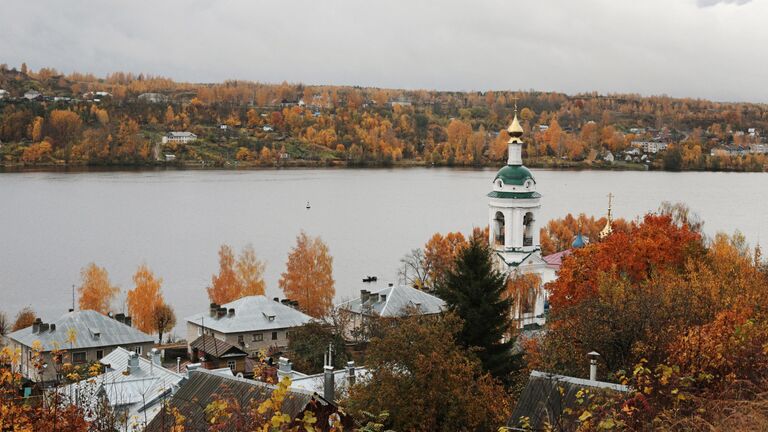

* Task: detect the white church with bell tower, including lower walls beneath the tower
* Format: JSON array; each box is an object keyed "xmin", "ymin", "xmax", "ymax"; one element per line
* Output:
[{"xmin": 488, "ymin": 107, "xmax": 560, "ymax": 327}]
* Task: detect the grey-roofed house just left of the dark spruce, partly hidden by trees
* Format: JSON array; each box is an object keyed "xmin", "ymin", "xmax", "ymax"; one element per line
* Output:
[{"xmin": 336, "ymin": 285, "xmax": 446, "ymax": 340}]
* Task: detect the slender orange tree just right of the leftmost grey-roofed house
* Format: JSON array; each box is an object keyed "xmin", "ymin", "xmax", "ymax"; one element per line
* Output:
[{"xmin": 126, "ymin": 264, "xmax": 164, "ymax": 333}]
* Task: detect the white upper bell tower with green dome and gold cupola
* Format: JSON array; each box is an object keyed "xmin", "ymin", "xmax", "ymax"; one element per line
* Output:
[{"xmin": 488, "ymin": 104, "xmax": 541, "ymax": 270}]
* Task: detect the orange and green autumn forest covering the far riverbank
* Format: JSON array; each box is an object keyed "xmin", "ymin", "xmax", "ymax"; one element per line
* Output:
[{"xmin": 0, "ymin": 64, "xmax": 768, "ymax": 171}]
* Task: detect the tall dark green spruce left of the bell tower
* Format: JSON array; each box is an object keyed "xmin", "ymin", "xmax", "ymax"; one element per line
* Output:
[{"xmin": 437, "ymin": 236, "xmax": 519, "ymax": 383}]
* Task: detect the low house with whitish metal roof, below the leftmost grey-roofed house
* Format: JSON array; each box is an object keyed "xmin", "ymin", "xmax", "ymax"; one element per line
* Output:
[{"xmin": 60, "ymin": 347, "xmax": 186, "ymax": 430}]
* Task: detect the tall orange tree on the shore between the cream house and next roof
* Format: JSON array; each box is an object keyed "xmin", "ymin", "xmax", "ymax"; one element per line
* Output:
[{"xmin": 279, "ymin": 231, "xmax": 336, "ymax": 318}]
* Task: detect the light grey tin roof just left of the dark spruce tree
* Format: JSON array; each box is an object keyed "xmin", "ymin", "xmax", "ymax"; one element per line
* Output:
[{"xmin": 338, "ymin": 285, "xmax": 446, "ymax": 317}]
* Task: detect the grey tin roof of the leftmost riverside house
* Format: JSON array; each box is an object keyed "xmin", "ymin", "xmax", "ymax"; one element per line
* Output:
[{"xmin": 8, "ymin": 310, "xmax": 155, "ymax": 352}]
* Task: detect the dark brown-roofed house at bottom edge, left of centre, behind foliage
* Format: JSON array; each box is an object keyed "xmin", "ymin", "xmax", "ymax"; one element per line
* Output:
[{"xmin": 145, "ymin": 369, "xmax": 353, "ymax": 432}]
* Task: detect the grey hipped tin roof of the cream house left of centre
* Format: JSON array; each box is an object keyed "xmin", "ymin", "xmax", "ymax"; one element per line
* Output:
[{"xmin": 185, "ymin": 296, "xmax": 312, "ymax": 333}]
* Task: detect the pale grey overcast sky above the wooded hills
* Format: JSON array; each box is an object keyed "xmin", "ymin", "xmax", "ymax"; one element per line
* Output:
[{"xmin": 0, "ymin": 0, "xmax": 768, "ymax": 102}]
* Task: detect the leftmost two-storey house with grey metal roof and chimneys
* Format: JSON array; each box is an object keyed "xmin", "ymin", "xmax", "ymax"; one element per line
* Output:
[{"xmin": 6, "ymin": 310, "xmax": 154, "ymax": 382}]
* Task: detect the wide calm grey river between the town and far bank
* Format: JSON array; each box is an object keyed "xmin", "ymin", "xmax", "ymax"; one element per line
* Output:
[{"xmin": 0, "ymin": 168, "xmax": 768, "ymax": 336}]
